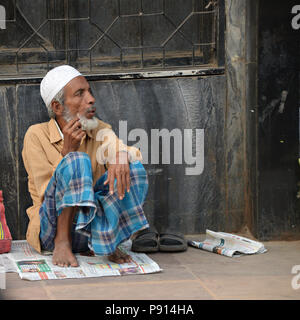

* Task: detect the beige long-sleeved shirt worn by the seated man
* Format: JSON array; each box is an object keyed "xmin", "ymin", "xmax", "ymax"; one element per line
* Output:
[{"xmin": 22, "ymin": 119, "xmax": 142, "ymax": 252}]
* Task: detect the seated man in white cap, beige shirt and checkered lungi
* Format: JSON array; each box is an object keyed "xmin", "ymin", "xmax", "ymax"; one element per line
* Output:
[{"xmin": 22, "ymin": 66, "xmax": 149, "ymax": 267}]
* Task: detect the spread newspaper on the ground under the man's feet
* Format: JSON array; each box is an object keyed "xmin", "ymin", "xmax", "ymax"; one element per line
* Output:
[{"xmin": 0, "ymin": 240, "xmax": 162, "ymax": 280}]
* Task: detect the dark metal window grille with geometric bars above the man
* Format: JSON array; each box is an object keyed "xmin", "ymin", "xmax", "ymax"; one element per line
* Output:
[{"xmin": 0, "ymin": 0, "xmax": 222, "ymax": 78}]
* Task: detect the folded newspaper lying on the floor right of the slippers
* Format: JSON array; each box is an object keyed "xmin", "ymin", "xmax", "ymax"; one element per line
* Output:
[{"xmin": 188, "ymin": 230, "xmax": 267, "ymax": 257}]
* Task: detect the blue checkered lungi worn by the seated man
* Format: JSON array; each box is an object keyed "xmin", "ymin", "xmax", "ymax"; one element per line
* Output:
[{"xmin": 39, "ymin": 152, "xmax": 149, "ymax": 255}]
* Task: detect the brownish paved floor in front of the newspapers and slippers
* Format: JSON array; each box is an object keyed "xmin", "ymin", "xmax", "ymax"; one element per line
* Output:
[{"xmin": 0, "ymin": 235, "xmax": 300, "ymax": 300}]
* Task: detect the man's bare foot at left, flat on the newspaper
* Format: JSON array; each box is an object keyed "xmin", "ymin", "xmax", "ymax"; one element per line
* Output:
[{"xmin": 52, "ymin": 241, "xmax": 78, "ymax": 267}]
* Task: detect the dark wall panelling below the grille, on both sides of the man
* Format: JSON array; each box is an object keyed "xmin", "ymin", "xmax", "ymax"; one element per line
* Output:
[{"xmin": 0, "ymin": 76, "xmax": 226, "ymax": 239}]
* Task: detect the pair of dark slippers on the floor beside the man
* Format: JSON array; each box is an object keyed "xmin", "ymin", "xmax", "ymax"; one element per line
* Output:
[{"xmin": 131, "ymin": 229, "xmax": 187, "ymax": 253}]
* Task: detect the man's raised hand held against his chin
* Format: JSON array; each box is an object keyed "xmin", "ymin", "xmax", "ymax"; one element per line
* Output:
[{"xmin": 61, "ymin": 118, "xmax": 85, "ymax": 156}]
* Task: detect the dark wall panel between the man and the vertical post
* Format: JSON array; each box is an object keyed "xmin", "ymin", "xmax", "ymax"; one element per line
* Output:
[{"xmin": 92, "ymin": 76, "xmax": 226, "ymax": 233}]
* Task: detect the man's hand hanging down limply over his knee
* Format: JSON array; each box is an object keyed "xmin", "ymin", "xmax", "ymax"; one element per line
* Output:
[{"xmin": 104, "ymin": 152, "xmax": 130, "ymax": 200}]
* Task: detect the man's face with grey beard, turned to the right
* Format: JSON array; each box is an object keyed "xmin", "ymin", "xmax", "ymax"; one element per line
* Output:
[{"xmin": 64, "ymin": 76, "xmax": 98, "ymax": 130}]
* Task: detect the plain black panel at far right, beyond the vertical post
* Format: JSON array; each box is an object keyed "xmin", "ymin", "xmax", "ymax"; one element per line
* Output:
[{"xmin": 257, "ymin": 0, "xmax": 300, "ymax": 239}]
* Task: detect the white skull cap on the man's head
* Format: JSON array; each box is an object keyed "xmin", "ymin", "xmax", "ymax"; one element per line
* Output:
[{"xmin": 40, "ymin": 65, "xmax": 82, "ymax": 106}]
